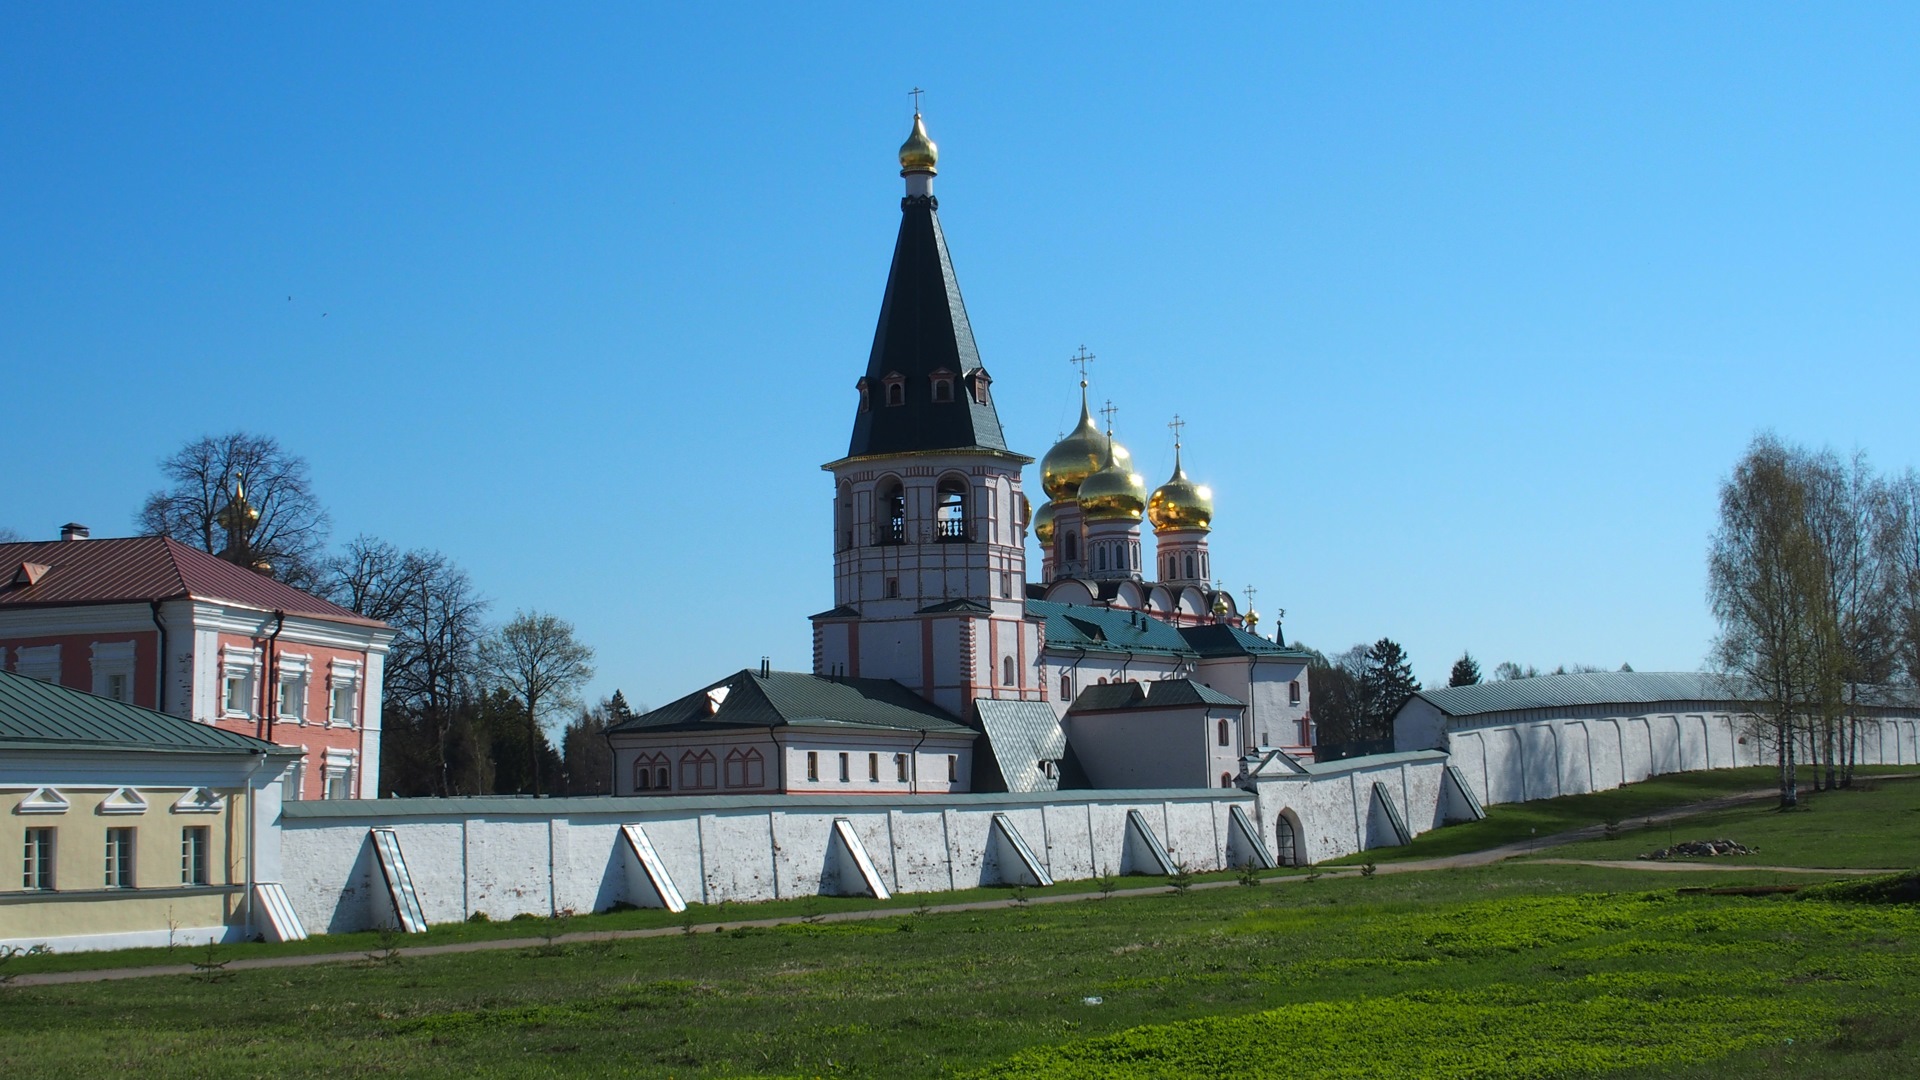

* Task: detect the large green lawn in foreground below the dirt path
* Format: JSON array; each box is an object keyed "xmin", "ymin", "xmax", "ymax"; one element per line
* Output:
[{"xmin": 0, "ymin": 863, "xmax": 1920, "ymax": 1080}]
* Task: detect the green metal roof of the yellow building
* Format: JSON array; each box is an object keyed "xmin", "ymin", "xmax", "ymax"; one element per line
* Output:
[{"xmin": 0, "ymin": 671, "xmax": 300, "ymax": 757}]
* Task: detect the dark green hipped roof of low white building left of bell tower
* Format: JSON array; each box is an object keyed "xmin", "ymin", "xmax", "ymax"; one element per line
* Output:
[{"xmin": 609, "ymin": 671, "xmax": 977, "ymax": 734}]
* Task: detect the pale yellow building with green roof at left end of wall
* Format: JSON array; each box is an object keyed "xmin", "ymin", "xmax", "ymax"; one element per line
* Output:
[{"xmin": 0, "ymin": 671, "xmax": 300, "ymax": 951}]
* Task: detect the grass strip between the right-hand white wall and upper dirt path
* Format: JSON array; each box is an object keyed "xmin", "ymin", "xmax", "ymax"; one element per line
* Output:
[{"xmin": 1329, "ymin": 767, "xmax": 1914, "ymax": 867}]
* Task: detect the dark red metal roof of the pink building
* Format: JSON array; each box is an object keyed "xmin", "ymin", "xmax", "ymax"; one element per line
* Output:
[{"xmin": 0, "ymin": 536, "xmax": 386, "ymax": 626}]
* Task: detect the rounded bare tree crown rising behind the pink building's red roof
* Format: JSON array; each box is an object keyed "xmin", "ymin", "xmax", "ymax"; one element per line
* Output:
[{"xmin": 134, "ymin": 430, "xmax": 332, "ymax": 588}]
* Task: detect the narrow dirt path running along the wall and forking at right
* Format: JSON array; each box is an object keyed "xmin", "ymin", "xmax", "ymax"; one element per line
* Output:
[{"xmin": 8, "ymin": 788, "xmax": 1899, "ymax": 986}]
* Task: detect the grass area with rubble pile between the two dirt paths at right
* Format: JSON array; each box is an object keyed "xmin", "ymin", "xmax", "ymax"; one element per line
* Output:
[{"xmin": 1542, "ymin": 778, "xmax": 1920, "ymax": 867}]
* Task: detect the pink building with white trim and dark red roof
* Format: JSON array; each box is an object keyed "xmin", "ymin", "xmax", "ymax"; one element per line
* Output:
[{"xmin": 0, "ymin": 525, "xmax": 394, "ymax": 799}]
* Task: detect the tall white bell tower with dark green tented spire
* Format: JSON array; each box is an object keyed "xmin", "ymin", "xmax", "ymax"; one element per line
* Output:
[{"xmin": 812, "ymin": 111, "xmax": 1044, "ymax": 717}]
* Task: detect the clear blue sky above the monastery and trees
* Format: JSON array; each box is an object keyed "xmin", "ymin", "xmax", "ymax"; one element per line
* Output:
[{"xmin": 0, "ymin": 0, "xmax": 1920, "ymax": 705}]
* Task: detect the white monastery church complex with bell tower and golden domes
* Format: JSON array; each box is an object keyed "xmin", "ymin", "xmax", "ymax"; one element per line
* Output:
[{"xmin": 609, "ymin": 113, "xmax": 1313, "ymax": 796}]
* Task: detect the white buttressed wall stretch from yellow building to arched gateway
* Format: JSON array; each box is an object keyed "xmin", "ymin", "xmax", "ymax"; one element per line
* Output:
[{"xmin": 280, "ymin": 790, "xmax": 1258, "ymax": 932}]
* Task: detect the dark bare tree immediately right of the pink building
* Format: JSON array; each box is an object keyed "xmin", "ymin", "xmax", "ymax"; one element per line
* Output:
[{"xmin": 321, "ymin": 536, "xmax": 488, "ymax": 796}]
